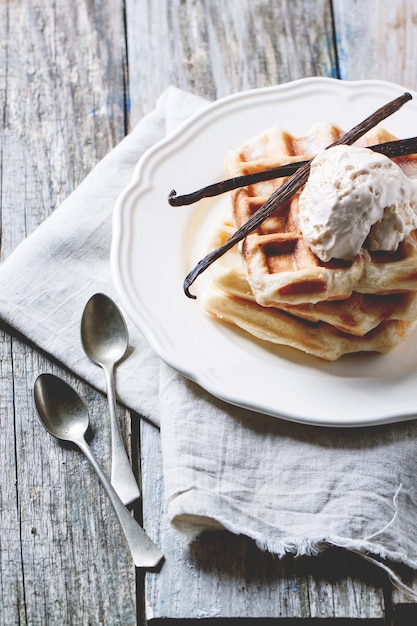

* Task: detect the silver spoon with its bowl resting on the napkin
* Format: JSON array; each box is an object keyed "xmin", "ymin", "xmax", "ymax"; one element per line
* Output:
[{"xmin": 81, "ymin": 293, "xmax": 140, "ymax": 504}]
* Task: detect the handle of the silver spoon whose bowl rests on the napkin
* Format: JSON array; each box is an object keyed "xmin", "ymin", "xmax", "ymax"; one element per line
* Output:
[{"xmin": 103, "ymin": 365, "xmax": 140, "ymax": 504}]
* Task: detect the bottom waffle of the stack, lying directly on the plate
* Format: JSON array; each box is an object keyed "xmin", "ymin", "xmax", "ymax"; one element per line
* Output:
[{"xmin": 202, "ymin": 286, "xmax": 415, "ymax": 361}]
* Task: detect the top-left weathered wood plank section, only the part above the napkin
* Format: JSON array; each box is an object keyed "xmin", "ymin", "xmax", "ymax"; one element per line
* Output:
[{"xmin": 0, "ymin": 0, "xmax": 126, "ymax": 234}]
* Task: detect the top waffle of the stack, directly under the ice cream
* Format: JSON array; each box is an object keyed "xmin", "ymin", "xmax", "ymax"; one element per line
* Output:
[{"xmin": 225, "ymin": 123, "xmax": 417, "ymax": 306}]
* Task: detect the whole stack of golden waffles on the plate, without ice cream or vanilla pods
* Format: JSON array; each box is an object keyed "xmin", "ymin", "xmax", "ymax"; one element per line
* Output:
[{"xmin": 202, "ymin": 124, "xmax": 417, "ymax": 361}]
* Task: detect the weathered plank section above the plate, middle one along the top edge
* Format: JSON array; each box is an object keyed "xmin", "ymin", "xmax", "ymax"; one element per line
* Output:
[{"xmin": 126, "ymin": 0, "xmax": 336, "ymax": 125}]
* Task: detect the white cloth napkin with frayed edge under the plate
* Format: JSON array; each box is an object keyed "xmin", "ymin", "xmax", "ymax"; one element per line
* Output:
[{"xmin": 0, "ymin": 87, "xmax": 417, "ymax": 580}]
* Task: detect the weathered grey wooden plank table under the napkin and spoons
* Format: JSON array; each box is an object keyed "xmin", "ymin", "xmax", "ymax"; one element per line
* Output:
[{"xmin": 0, "ymin": 0, "xmax": 417, "ymax": 626}]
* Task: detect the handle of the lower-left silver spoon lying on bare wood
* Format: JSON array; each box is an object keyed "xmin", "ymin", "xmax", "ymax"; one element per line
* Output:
[{"xmin": 74, "ymin": 437, "xmax": 163, "ymax": 568}]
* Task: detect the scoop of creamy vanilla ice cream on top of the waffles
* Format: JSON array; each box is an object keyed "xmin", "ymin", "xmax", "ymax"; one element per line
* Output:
[{"xmin": 299, "ymin": 145, "xmax": 417, "ymax": 261}]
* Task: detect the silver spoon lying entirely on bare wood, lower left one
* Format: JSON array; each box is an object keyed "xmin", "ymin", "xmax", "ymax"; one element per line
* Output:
[{"xmin": 34, "ymin": 374, "xmax": 163, "ymax": 568}]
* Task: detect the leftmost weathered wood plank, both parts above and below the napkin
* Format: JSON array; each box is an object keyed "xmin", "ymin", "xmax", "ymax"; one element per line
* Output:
[{"xmin": 0, "ymin": 0, "xmax": 137, "ymax": 626}]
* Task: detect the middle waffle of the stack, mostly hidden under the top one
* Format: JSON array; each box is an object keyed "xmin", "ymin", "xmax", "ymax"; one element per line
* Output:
[{"xmin": 209, "ymin": 213, "xmax": 417, "ymax": 337}]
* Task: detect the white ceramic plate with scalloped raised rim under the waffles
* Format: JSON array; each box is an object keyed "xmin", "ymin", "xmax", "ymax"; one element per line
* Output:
[{"xmin": 111, "ymin": 78, "xmax": 417, "ymax": 426}]
